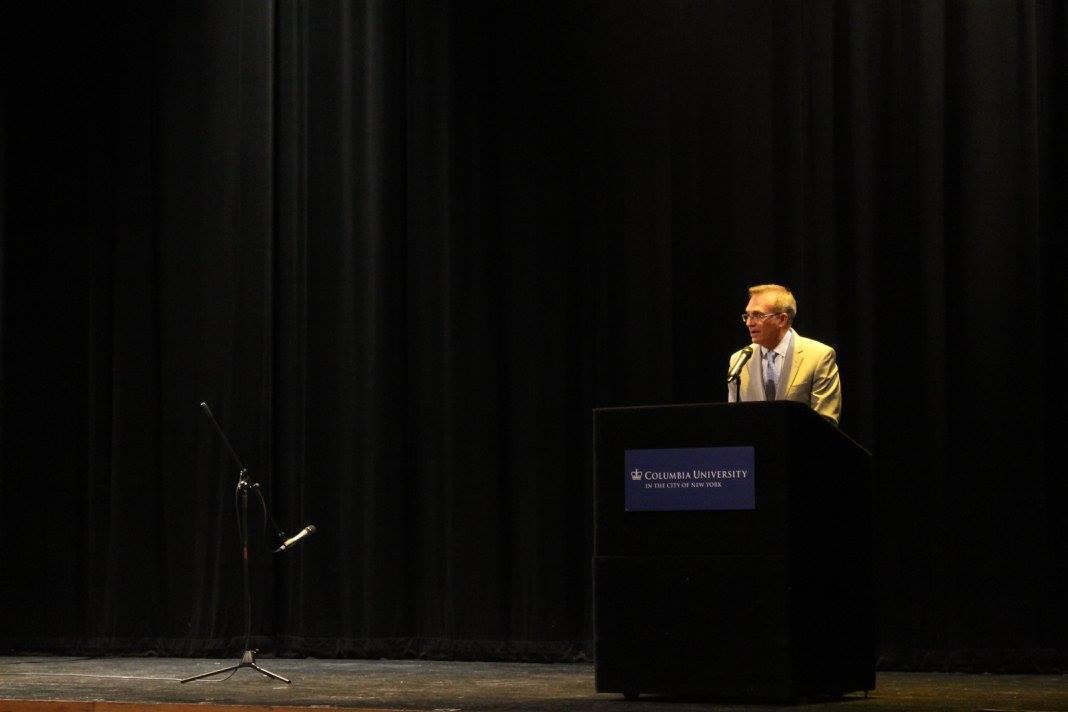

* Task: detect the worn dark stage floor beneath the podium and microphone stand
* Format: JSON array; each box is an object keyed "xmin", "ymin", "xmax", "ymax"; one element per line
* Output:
[{"xmin": 0, "ymin": 656, "xmax": 1068, "ymax": 712}]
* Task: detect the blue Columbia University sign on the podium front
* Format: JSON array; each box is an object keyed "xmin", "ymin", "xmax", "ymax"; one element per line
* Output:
[{"xmin": 624, "ymin": 446, "xmax": 756, "ymax": 511}]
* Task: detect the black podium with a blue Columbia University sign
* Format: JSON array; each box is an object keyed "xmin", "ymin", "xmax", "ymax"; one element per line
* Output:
[{"xmin": 593, "ymin": 401, "xmax": 876, "ymax": 701}]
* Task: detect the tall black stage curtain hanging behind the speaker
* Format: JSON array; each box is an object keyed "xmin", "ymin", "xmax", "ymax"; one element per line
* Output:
[{"xmin": 0, "ymin": 0, "xmax": 1068, "ymax": 670}]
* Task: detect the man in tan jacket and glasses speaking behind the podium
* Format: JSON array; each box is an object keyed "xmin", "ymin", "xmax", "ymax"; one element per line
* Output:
[{"xmin": 727, "ymin": 284, "xmax": 842, "ymax": 425}]
